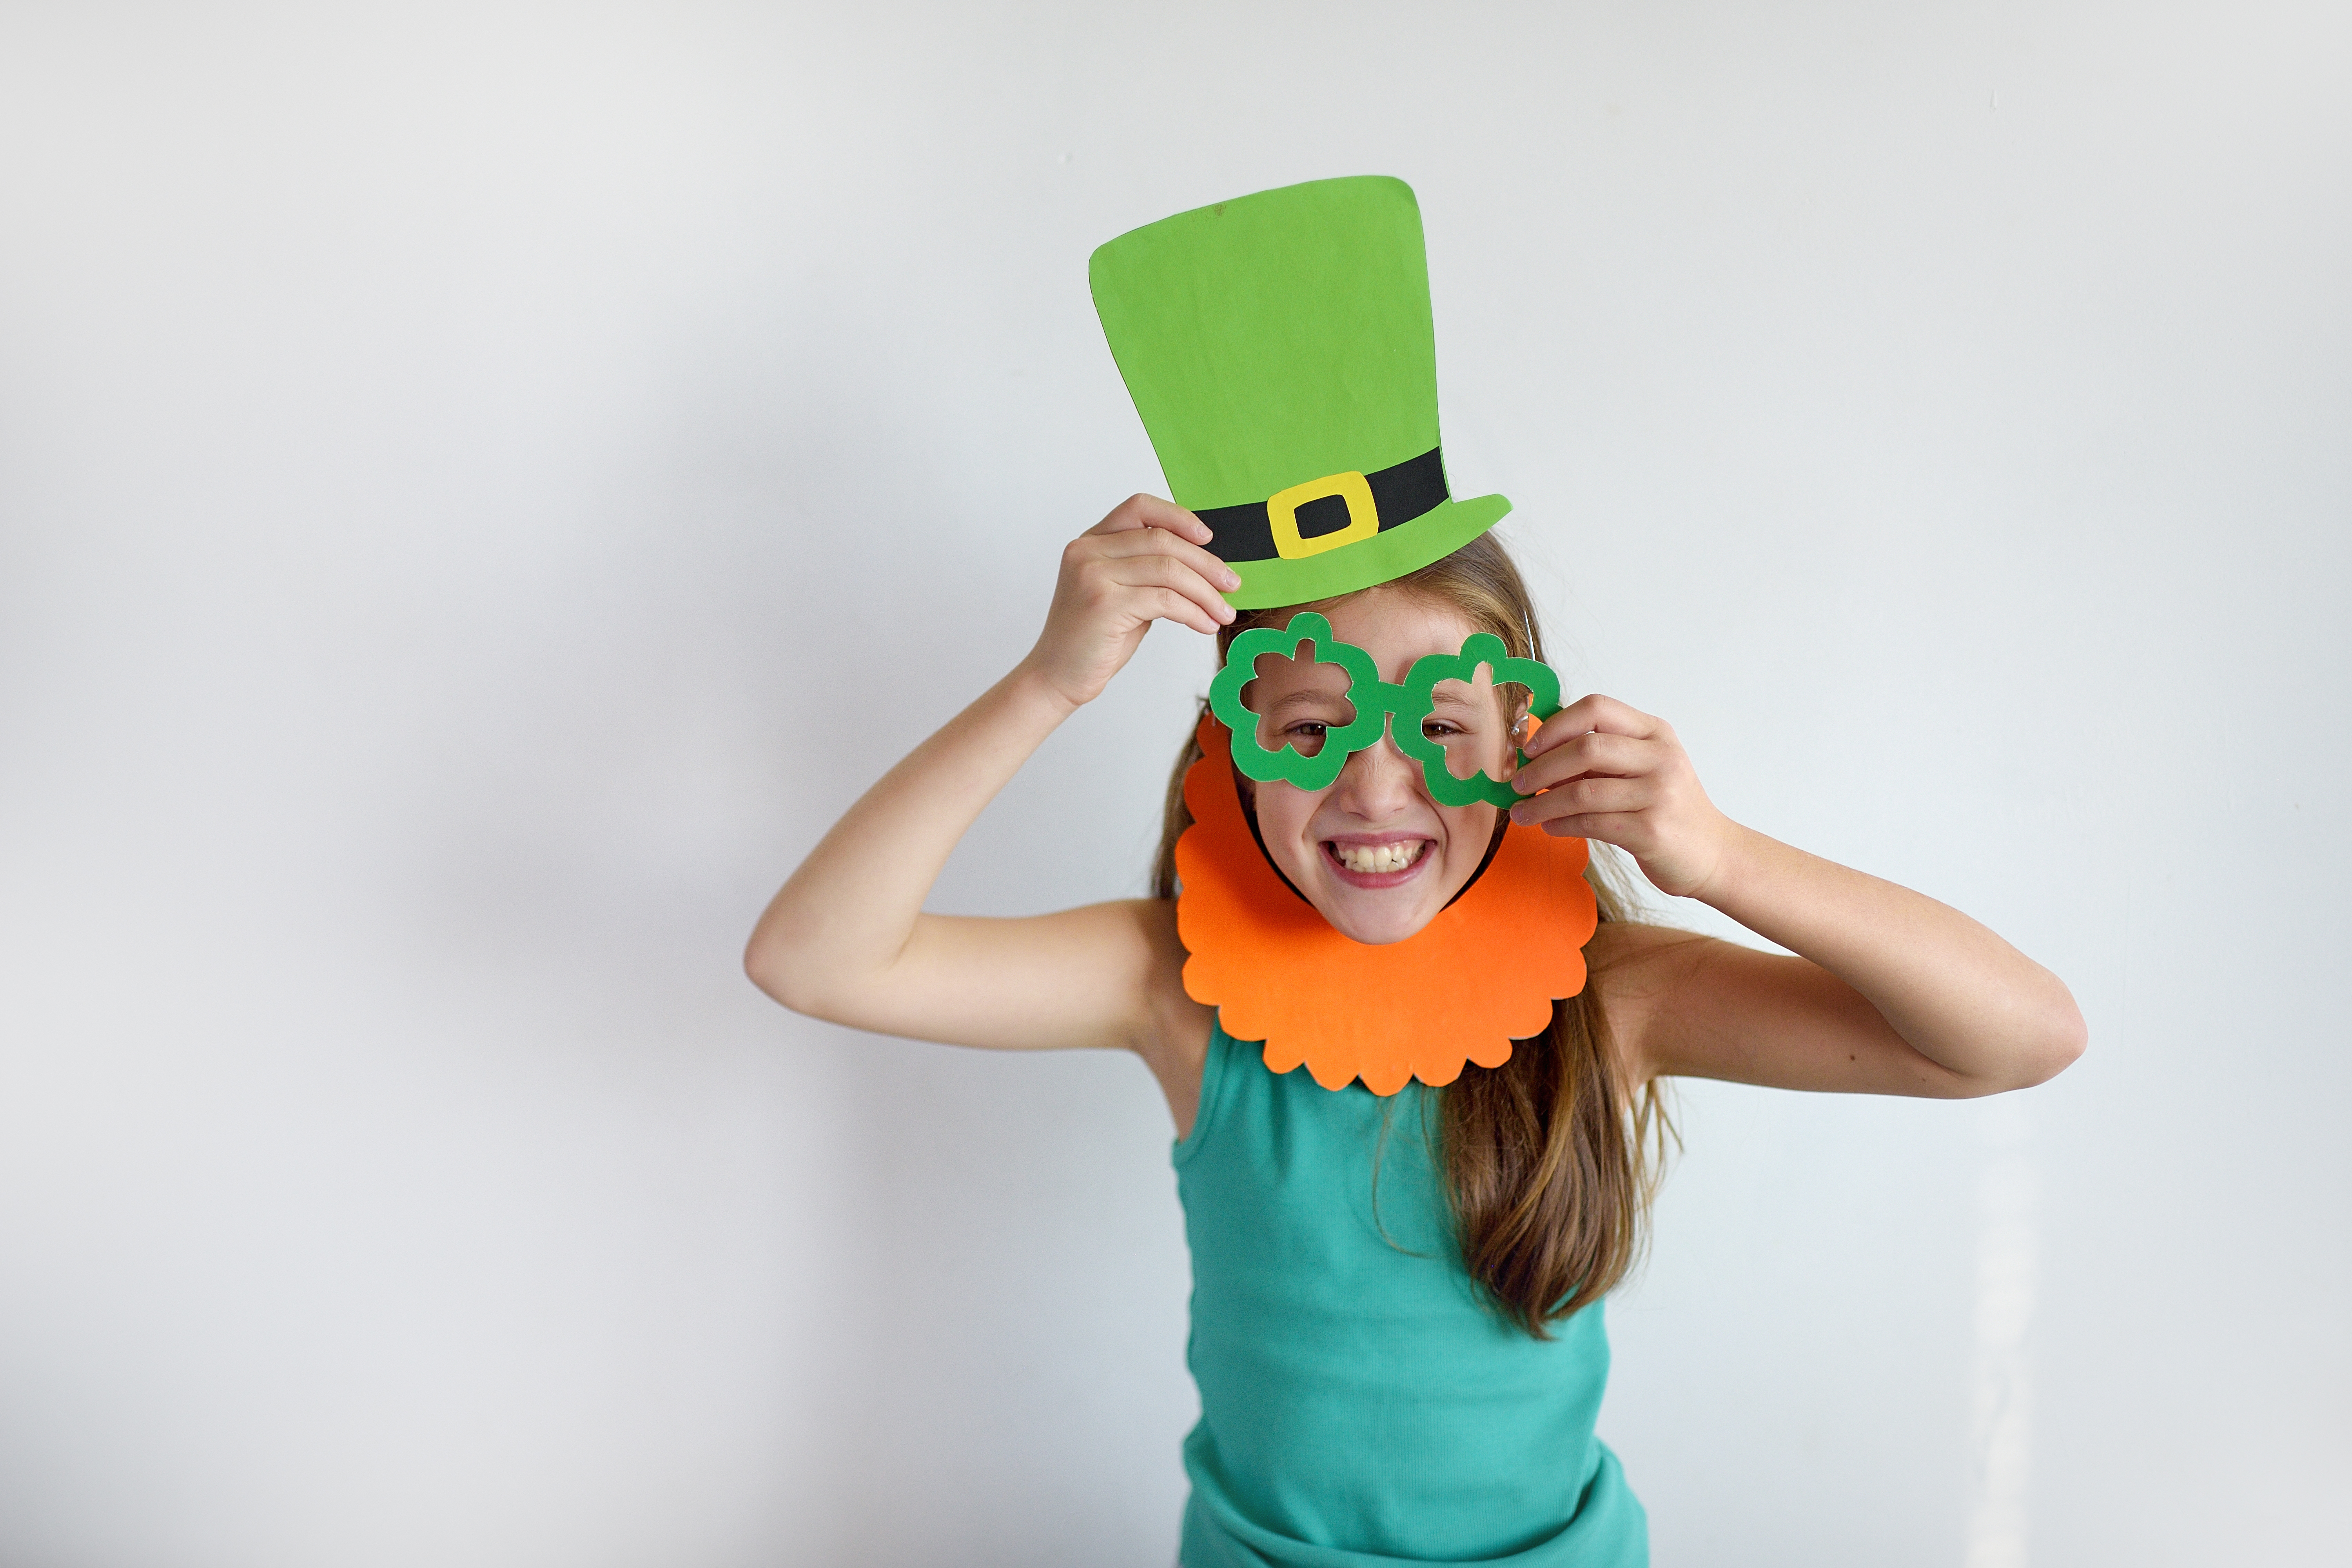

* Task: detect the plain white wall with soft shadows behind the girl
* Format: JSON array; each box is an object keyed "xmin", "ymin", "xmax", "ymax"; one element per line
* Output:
[{"xmin": 0, "ymin": 0, "xmax": 2352, "ymax": 1568}]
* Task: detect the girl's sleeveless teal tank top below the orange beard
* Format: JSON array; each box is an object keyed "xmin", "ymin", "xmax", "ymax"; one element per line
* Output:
[{"xmin": 1176, "ymin": 1027, "xmax": 1649, "ymax": 1568}]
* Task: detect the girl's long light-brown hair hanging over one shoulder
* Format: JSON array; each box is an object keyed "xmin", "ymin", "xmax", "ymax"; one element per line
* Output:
[{"xmin": 1152, "ymin": 534, "xmax": 1675, "ymax": 1340}]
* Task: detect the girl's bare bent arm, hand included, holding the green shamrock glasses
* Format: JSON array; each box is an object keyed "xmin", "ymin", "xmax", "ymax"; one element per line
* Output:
[{"xmin": 1512, "ymin": 696, "xmax": 2084, "ymax": 1098}]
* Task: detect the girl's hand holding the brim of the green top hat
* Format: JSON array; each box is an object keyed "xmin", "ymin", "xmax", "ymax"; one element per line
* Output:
[{"xmin": 1021, "ymin": 496, "xmax": 1242, "ymax": 708}]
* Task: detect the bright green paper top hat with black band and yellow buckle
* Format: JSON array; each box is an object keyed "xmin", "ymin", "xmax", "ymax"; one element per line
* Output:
[{"xmin": 1087, "ymin": 174, "xmax": 1510, "ymax": 609}]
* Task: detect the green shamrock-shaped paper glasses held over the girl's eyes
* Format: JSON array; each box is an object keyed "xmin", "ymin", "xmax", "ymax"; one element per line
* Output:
[{"xmin": 1209, "ymin": 609, "xmax": 1559, "ymax": 806}]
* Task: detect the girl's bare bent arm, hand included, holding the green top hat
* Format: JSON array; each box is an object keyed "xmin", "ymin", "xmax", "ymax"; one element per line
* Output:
[{"xmin": 743, "ymin": 496, "xmax": 1237, "ymax": 1077}]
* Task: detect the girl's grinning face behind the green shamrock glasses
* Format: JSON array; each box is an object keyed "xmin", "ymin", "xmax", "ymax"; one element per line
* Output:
[{"xmin": 1242, "ymin": 588, "xmax": 1517, "ymax": 943}]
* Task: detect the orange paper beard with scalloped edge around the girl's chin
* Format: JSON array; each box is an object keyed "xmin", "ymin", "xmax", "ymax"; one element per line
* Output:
[{"xmin": 1176, "ymin": 717, "xmax": 1599, "ymax": 1096}]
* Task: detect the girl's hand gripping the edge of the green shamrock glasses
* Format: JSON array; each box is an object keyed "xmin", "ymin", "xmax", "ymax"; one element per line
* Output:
[{"xmin": 1510, "ymin": 693, "xmax": 1738, "ymax": 898}]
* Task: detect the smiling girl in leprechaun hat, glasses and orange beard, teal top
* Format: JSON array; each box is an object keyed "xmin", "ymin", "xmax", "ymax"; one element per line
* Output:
[{"xmin": 746, "ymin": 181, "xmax": 2084, "ymax": 1568}]
